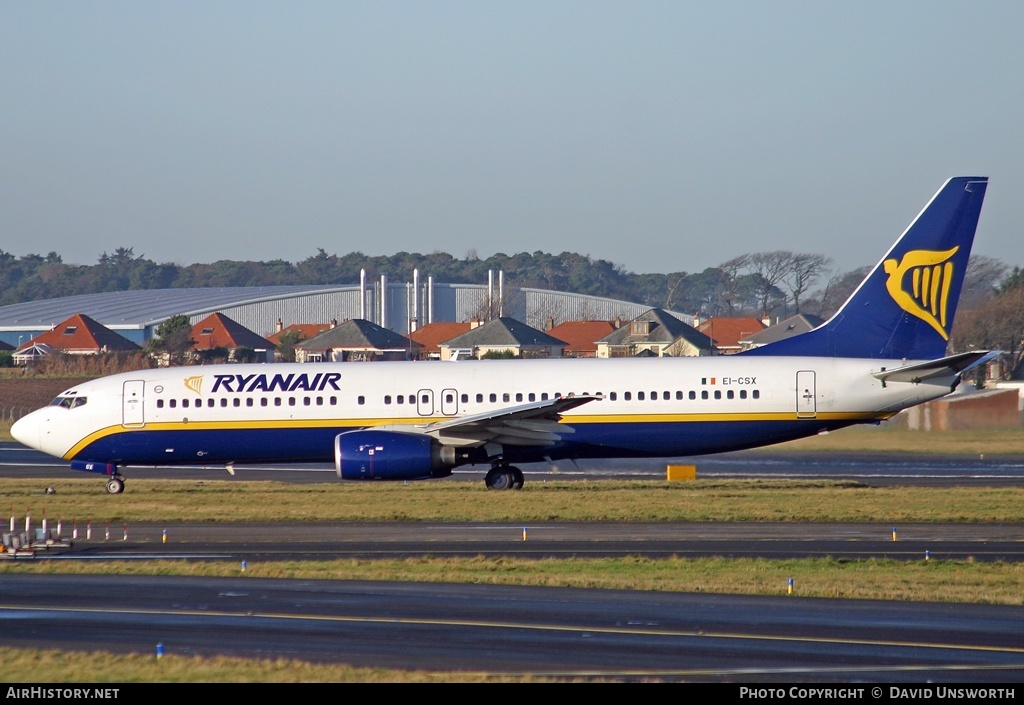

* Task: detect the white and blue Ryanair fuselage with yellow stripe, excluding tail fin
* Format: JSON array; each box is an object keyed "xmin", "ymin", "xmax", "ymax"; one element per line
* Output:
[{"xmin": 12, "ymin": 356, "xmax": 956, "ymax": 465}]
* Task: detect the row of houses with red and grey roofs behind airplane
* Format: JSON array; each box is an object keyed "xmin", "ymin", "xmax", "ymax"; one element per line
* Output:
[{"xmin": 8, "ymin": 308, "xmax": 821, "ymax": 365}]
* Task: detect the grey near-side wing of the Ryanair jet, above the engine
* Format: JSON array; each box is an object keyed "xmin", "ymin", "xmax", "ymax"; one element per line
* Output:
[{"xmin": 420, "ymin": 397, "xmax": 598, "ymax": 446}]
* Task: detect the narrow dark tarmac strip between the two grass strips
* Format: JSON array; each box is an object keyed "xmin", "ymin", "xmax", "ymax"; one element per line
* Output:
[{"xmin": 18, "ymin": 522, "xmax": 1024, "ymax": 563}]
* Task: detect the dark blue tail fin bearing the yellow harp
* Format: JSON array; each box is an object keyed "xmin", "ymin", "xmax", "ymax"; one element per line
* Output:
[{"xmin": 743, "ymin": 176, "xmax": 988, "ymax": 360}]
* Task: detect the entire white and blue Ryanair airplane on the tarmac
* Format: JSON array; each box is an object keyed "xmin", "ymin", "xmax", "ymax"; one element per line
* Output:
[{"xmin": 11, "ymin": 176, "xmax": 997, "ymax": 494}]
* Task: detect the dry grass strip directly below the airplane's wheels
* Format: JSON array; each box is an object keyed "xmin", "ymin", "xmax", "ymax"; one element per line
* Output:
[{"xmin": 8, "ymin": 470, "xmax": 1024, "ymax": 524}]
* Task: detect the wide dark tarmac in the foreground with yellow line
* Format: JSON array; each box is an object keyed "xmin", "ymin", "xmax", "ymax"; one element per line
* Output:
[{"xmin": 0, "ymin": 575, "xmax": 1024, "ymax": 683}]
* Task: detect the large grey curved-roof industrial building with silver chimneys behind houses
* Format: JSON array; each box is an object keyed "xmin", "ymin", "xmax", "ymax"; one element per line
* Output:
[{"xmin": 0, "ymin": 273, "xmax": 693, "ymax": 347}]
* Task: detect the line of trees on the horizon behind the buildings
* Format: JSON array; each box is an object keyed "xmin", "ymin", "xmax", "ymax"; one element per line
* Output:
[{"xmin": 6, "ymin": 247, "xmax": 1024, "ymax": 378}]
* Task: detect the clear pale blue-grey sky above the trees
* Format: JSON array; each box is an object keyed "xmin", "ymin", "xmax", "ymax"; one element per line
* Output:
[{"xmin": 0, "ymin": 0, "xmax": 1024, "ymax": 273}]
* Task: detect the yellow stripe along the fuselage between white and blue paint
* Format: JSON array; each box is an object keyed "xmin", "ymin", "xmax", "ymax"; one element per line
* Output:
[{"xmin": 63, "ymin": 412, "xmax": 892, "ymax": 460}]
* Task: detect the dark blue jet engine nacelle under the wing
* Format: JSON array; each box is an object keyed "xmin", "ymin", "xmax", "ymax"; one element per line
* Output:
[{"xmin": 334, "ymin": 430, "xmax": 452, "ymax": 480}]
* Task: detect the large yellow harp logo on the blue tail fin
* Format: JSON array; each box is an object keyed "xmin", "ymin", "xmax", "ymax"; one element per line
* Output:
[{"xmin": 884, "ymin": 246, "xmax": 959, "ymax": 340}]
